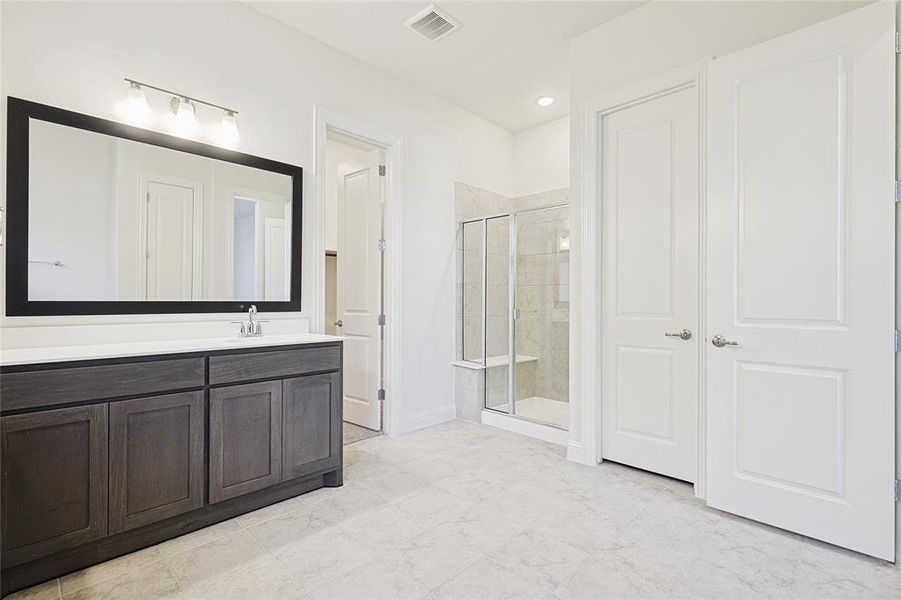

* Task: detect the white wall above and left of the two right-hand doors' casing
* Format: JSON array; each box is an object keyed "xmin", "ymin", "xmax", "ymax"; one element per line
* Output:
[{"xmin": 570, "ymin": 1, "xmax": 866, "ymax": 462}]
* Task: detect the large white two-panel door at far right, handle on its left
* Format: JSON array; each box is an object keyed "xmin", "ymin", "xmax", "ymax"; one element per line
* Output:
[{"xmin": 705, "ymin": 3, "xmax": 895, "ymax": 560}]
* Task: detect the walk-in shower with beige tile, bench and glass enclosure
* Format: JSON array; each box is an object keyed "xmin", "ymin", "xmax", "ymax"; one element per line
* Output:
[{"xmin": 455, "ymin": 183, "xmax": 569, "ymax": 428}]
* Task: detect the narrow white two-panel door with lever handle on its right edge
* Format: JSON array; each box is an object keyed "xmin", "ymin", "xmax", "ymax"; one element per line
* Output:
[{"xmin": 600, "ymin": 86, "xmax": 699, "ymax": 482}]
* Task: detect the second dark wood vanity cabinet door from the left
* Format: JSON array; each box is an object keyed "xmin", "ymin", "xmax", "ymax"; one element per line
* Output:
[{"xmin": 109, "ymin": 391, "xmax": 204, "ymax": 534}]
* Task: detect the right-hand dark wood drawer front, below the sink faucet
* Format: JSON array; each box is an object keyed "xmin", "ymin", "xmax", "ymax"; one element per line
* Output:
[{"xmin": 210, "ymin": 344, "xmax": 341, "ymax": 385}]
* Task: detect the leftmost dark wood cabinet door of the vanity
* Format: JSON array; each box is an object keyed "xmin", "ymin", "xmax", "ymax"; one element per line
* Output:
[{"xmin": 0, "ymin": 404, "xmax": 108, "ymax": 567}]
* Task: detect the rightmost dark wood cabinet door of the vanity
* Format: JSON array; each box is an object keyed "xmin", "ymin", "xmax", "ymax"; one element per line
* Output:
[{"xmin": 282, "ymin": 372, "xmax": 341, "ymax": 480}]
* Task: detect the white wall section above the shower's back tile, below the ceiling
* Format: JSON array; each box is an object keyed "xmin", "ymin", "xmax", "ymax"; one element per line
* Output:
[{"xmin": 513, "ymin": 117, "xmax": 569, "ymax": 197}]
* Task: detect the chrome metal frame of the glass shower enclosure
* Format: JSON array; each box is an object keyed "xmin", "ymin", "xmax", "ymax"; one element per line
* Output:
[{"xmin": 460, "ymin": 202, "xmax": 570, "ymax": 431}]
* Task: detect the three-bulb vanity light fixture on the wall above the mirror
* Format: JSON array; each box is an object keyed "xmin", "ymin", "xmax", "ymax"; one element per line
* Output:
[{"xmin": 123, "ymin": 77, "xmax": 240, "ymax": 148}]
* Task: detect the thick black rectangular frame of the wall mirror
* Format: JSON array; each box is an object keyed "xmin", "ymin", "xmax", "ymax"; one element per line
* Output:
[{"xmin": 5, "ymin": 97, "xmax": 303, "ymax": 317}]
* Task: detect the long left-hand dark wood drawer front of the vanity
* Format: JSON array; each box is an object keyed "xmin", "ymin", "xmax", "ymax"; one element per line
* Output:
[{"xmin": 0, "ymin": 358, "xmax": 204, "ymax": 411}]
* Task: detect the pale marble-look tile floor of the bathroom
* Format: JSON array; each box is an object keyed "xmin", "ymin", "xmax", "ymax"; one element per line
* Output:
[{"xmin": 10, "ymin": 421, "xmax": 901, "ymax": 600}]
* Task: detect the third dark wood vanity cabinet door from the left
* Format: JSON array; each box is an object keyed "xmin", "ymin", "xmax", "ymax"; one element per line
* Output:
[{"xmin": 210, "ymin": 381, "xmax": 282, "ymax": 503}]
